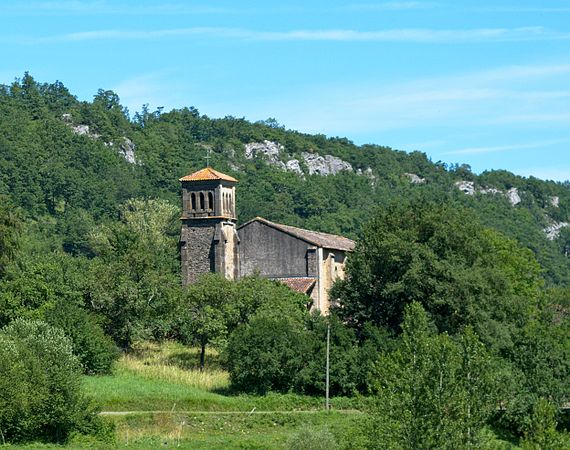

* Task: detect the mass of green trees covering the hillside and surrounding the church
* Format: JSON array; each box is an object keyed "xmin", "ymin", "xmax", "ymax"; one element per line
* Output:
[{"xmin": 0, "ymin": 74, "xmax": 570, "ymax": 448}]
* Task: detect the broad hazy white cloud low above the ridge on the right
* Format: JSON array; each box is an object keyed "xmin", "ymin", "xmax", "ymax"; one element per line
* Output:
[{"xmin": 248, "ymin": 64, "xmax": 570, "ymax": 139}]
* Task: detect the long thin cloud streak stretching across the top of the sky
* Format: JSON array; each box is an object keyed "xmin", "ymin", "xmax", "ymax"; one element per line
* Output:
[{"xmin": 9, "ymin": 27, "xmax": 570, "ymax": 44}]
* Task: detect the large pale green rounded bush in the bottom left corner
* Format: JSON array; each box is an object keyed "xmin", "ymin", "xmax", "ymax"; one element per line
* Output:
[{"xmin": 0, "ymin": 319, "xmax": 107, "ymax": 442}]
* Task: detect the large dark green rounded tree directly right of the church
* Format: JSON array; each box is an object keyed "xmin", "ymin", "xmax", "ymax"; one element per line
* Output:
[{"xmin": 331, "ymin": 198, "xmax": 542, "ymax": 349}]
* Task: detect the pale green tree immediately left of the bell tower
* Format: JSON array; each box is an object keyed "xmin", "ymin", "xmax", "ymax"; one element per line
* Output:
[{"xmin": 87, "ymin": 199, "xmax": 180, "ymax": 348}]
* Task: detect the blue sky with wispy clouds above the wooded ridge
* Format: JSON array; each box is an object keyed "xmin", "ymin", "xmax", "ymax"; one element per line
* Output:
[{"xmin": 0, "ymin": 0, "xmax": 570, "ymax": 180}]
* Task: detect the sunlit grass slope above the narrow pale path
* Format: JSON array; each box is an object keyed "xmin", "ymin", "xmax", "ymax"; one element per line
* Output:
[{"xmin": 84, "ymin": 342, "xmax": 357, "ymax": 412}]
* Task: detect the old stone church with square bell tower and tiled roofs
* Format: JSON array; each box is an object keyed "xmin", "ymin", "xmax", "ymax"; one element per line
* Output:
[{"xmin": 180, "ymin": 167, "xmax": 354, "ymax": 314}]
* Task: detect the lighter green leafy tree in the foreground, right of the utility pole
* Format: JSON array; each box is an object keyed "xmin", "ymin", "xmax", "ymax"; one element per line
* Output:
[{"xmin": 368, "ymin": 302, "xmax": 500, "ymax": 449}]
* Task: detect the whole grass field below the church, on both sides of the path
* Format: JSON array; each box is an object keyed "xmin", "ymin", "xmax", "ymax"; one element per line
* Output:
[{"xmin": 77, "ymin": 343, "xmax": 362, "ymax": 449}]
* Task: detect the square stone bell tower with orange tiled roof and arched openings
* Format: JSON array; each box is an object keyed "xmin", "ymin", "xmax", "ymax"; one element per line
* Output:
[{"xmin": 180, "ymin": 167, "xmax": 239, "ymax": 286}]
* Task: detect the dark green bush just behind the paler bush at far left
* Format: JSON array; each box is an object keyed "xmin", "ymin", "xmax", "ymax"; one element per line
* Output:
[{"xmin": 46, "ymin": 302, "xmax": 119, "ymax": 375}]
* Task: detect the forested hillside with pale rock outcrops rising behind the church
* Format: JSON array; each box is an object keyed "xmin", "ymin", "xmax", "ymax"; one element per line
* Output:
[{"xmin": 0, "ymin": 74, "xmax": 570, "ymax": 284}]
